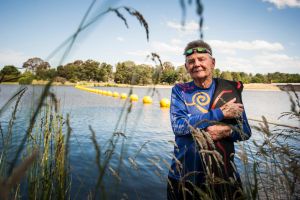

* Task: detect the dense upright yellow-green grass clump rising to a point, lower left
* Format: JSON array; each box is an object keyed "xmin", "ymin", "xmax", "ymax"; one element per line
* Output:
[{"xmin": 25, "ymin": 99, "xmax": 70, "ymax": 199}]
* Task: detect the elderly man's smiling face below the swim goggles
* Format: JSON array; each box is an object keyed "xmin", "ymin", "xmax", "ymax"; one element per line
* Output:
[{"xmin": 185, "ymin": 52, "xmax": 215, "ymax": 80}]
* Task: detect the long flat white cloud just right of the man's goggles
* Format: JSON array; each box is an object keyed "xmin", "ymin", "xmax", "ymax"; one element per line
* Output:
[{"xmin": 208, "ymin": 40, "xmax": 284, "ymax": 54}]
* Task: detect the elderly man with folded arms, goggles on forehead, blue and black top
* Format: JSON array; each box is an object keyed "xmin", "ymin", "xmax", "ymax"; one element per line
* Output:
[{"xmin": 167, "ymin": 40, "xmax": 251, "ymax": 199}]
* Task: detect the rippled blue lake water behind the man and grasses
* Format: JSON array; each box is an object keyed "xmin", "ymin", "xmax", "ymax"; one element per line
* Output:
[{"xmin": 0, "ymin": 85, "xmax": 299, "ymax": 199}]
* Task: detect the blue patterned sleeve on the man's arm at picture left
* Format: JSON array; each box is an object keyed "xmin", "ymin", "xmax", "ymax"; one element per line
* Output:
[{"xmin": 170, "ymin": 85, "xmax": 224, "ymax": 135}]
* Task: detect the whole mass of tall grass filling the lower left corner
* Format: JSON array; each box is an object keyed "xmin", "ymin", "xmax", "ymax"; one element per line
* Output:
[{"xmin": 0, "ymin": 87, "xmax": 70, "ymax": 199}]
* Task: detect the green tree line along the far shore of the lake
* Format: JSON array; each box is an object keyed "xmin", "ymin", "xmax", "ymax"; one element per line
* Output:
[{"xmin": 0, "ymin": 58, "xmax": 300, "ymax": 85}]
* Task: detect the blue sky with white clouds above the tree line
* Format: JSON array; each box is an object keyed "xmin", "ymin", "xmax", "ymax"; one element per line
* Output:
[{"xmin": 0, "ymin": 0, "xmax": 300, "ymax": 74}]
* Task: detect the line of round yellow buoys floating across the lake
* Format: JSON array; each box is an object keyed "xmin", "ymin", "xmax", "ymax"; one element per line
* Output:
[{"xmin": 75, "ymin": 85, "xmax": 170, "ymax": 108}]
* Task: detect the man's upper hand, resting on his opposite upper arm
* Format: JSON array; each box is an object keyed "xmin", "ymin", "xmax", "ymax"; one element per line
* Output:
[{"xmin": 220, "ymin": 98, "xmax": 244, "ymax": 119}]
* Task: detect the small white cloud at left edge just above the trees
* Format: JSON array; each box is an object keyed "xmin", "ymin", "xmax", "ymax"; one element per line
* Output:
[{"xmin": 0, "ymin": 50, "xmax": 28, "ymax": 67}]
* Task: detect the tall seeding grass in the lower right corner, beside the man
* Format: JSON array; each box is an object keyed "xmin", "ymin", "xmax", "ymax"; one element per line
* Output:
[{"xmin": 245, "ymin": 91, "xmax": 300, "ymax": 199}]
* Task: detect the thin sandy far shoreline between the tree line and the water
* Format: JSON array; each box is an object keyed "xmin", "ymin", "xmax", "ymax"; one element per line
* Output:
[{"xmin": 1, "ymin": 80, "xmax": 300, "ymax": 91}]
